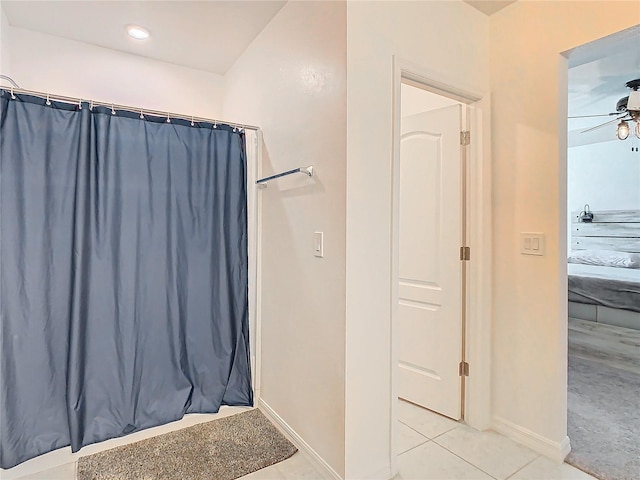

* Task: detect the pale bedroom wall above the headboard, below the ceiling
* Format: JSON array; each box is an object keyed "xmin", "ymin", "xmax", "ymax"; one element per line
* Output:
[{"xmin": 567, "ymin": 139, "xmax": 640, "ymax": 212}]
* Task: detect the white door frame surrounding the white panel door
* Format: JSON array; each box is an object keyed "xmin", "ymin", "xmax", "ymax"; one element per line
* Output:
[{"xmin": 389, "ymin": 56, "xmax": 492, "ymax": 475}]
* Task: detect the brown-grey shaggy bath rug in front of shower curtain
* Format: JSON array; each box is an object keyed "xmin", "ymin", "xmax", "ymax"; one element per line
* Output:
[{"xmin": 77, "ymin": 409, "xmax": 297, "ymax": 480}]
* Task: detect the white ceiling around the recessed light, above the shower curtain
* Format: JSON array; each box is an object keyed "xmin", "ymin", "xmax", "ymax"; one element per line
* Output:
[{"xmin": 2, "ymin": 0, "xmax": 286, "ymax": 75}]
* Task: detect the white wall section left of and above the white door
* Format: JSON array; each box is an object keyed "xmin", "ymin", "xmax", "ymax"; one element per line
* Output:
[{"xmin": 345, "ymin": 1, "xmax": 489, "ymax": 479}]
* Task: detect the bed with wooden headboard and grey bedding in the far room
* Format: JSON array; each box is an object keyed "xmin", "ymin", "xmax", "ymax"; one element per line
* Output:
[{"xmin": 568, "ymin": 210, "xmax": 640, "ymax": 329}]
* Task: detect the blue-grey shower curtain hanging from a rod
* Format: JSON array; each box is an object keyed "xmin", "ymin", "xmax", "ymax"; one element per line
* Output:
[{"xmin": 0, "ymin": 90, "xmax": 253, "ymax": 468}]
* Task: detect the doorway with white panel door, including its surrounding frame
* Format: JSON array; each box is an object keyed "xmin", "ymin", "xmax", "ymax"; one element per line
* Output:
[{"xmin": 390, "ymin": 58, "xmax": 491, "ymax": 472}]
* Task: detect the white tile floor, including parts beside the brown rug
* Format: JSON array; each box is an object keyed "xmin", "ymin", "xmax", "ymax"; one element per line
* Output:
[{"xmin": 3, "ymin": 401, "xmax": 594, "ymax": 480}]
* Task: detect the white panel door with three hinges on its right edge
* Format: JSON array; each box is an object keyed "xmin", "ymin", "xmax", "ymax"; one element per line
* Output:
[{"xmin": 398, "ymin": 105, "xmax": 463, "ymax": 420}]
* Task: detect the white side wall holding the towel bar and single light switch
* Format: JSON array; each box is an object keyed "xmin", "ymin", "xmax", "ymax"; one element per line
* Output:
[{"xmin": 224, "ymin": 2, "xmax": 346, "ymax": 475}]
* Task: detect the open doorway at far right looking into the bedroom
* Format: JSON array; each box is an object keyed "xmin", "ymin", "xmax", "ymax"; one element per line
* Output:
[{"xmin": 566, "ymin": 26, "xmax": 640, "ymax": 479}]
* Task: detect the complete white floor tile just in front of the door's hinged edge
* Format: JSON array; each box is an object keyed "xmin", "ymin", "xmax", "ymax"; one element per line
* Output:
[{"xmin": 433, "ymin": 425, "xmax": 539, "ymax": 480}]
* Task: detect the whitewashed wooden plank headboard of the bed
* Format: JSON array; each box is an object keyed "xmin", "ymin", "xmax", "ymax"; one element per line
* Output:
[{"xmin": 571, "ymin": 210, "xmax": 640, "ymax": 252}]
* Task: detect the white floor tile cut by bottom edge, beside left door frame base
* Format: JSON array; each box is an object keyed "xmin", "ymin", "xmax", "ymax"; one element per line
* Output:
[{"xmin": 394, "ymin": 442, "xmax": 492, "ymax": 480}]
